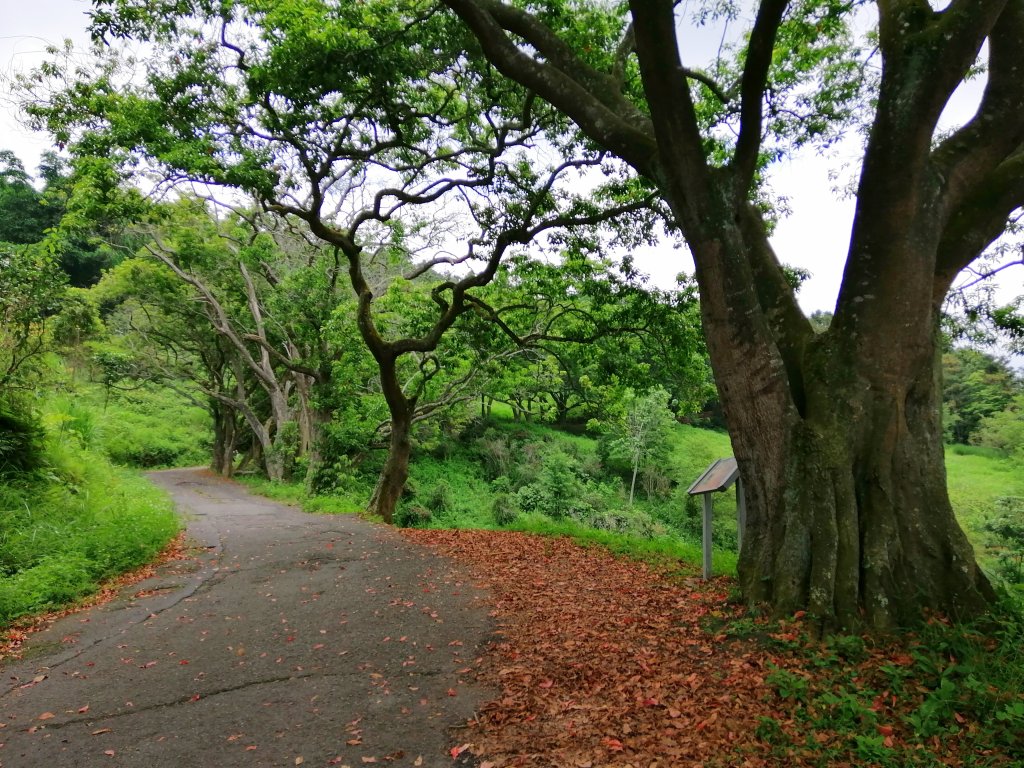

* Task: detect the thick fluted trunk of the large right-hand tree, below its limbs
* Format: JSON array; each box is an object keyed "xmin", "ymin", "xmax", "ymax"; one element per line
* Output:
[{"xmin": 697, "ymin": 210, "xmax": 992, "ymax": 631}]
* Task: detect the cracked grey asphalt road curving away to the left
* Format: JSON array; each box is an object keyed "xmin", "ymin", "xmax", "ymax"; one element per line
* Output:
[{"xmin": 0, "ymin": 470, "xmax": 492, "ymax": 768}]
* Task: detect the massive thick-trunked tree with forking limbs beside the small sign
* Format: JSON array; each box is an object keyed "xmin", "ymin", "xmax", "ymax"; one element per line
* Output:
[{"xmin": 443, "ymin": 0, "xmax": 1024, "ymax": 628}]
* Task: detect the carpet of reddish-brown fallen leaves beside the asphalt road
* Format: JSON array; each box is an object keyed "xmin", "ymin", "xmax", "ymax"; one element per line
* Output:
[{"xmin": 403, "ymin": 529, "xmax": 788, "ymax": 768}]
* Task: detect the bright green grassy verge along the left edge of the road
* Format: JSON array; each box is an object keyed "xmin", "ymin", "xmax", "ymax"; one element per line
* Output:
[{"xmin": 0, "ymin": 435, "xmax": 180, "ymax": 626}]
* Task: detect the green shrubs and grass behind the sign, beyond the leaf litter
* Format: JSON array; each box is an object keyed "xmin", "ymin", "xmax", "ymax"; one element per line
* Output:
[{"xmin": 396, "ymin": 420, "xmax": 736, "ymax": 573}]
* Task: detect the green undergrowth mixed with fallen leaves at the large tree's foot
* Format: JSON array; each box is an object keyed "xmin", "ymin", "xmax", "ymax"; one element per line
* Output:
[{"xmin": 737, "ymin": 598, "xmax": 1024, "ymax": 768}]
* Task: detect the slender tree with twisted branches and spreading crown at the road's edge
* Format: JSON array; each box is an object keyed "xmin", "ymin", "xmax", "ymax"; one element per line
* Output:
[{"xmin": 25, "ymin": 0, "xmax": 651, "ymax": 521}]
